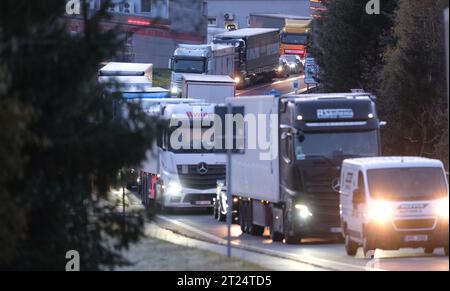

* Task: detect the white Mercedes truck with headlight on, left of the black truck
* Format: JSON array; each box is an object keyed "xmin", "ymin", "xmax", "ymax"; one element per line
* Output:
[{"xmin": 139, "ymin": 98, "xmax": 226, "ymax": 211}]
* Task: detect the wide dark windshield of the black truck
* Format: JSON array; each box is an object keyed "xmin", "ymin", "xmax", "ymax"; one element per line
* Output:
[{"xmin": 295, "ymin": 130, "xmax": 379, "ymax": 160}]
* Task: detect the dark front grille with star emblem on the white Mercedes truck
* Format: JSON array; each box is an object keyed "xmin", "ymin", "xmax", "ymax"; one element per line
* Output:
[{"xmin": 178, "ymin": 164, "xmax": 226, "ymax": 190}]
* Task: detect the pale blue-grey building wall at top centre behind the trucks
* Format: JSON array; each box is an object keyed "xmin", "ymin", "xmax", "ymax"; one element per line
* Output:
[{"xmin": 208, "ymin": 0, "xmax": 311, "ymax": 29}]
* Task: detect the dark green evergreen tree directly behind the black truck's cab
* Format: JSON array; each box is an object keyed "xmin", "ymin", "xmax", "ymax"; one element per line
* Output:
[{"xmin": 312, "ymin": 0, "xmax": 397, "ymax": 92}]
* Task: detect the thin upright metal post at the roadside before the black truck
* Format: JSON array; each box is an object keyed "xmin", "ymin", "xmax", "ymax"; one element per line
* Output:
[{"xmin": 225, "ymin": 103, "xmax": 234, "ymax": 257}]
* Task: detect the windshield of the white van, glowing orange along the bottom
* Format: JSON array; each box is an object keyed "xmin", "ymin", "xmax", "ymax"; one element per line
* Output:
[{"xmin": 367, "ymin": 167, "xmax": 448, "ymax": 201}]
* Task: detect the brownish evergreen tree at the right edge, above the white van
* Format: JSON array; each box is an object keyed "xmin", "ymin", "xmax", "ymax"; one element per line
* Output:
[{"xmin": 379, "ymin": 0, "xmax": 448, "ymax": 164}]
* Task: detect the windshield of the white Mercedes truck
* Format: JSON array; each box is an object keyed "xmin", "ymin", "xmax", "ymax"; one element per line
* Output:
[{"xmin": 167, "ymin": 127, "xmax": 218, "ymax": 154}]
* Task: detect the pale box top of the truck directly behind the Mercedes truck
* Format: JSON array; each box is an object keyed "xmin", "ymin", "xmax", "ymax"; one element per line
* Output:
[{"xmin": 181, "ymin": 74, "xmax": 236, "ymax": 104}]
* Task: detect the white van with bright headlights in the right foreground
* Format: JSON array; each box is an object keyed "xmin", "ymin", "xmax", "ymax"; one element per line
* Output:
[{"xmin": 340, "ymin": 157, "xmax": 449, "ymax": 256}]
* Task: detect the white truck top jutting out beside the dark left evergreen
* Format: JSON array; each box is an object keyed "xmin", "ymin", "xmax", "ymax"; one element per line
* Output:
[{"xmin": 99, "ymin": 62, "xmax": 153, "ymax": 86}]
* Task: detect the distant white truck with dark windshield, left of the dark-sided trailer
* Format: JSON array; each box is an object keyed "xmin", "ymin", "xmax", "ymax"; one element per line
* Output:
[{"xmin": 169, "ymin": 44, "xmax": 235, "ymax": 96}]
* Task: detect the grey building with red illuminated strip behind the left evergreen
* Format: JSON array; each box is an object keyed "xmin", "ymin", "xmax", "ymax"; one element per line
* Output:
[{"xmin": 68, "ymin": 0, "xmax": 207, "ymax": 68}]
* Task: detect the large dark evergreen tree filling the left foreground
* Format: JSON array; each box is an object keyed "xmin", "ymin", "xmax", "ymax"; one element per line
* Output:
[{"xmin": 0, "ymin": 0, "xmax": 158, "ymax": 270}]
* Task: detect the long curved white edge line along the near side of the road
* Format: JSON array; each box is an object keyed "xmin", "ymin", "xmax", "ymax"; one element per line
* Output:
[{"xmin": 157, "ymin": 215, "xmax": 386, "ymax": 271}]
